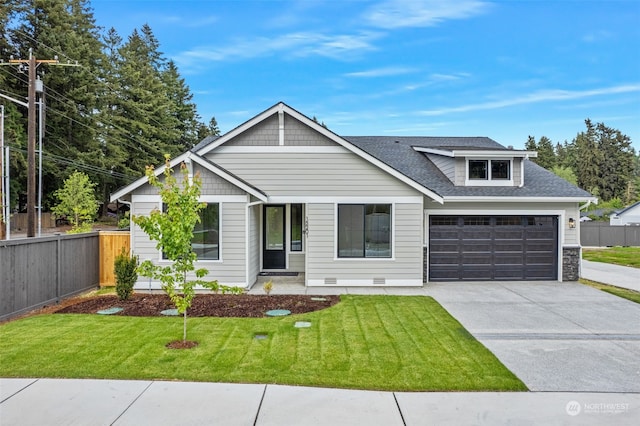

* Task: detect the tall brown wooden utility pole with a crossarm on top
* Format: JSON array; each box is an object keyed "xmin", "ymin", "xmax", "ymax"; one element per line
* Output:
[{"xmin": 9, "ymin": 49, "xmax": 58, "ymax": 237}]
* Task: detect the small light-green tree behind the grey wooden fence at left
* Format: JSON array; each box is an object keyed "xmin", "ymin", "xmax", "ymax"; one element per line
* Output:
[{"xmin": 52, "ymin": 172, "xmax": 98, "ymax": 232}]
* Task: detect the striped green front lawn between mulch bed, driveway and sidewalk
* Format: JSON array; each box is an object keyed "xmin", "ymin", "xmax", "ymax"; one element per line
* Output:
[{"xmin": 0, "ymin": 296, "xmax": 526, "ymax": 391}]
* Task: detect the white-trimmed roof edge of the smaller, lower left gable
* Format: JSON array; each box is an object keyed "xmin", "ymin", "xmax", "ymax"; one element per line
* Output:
[{"xmin": 110, "ymin": 151, "xmax": 268, "ymax": 202}]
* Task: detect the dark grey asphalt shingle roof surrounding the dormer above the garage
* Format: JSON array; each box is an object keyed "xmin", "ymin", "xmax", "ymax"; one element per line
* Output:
[{"xmin": 342, "ymin": 136, "xmax": 592, "ymax": 198}]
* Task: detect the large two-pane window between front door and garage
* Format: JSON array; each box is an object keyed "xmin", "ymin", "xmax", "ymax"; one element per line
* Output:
[{"xmin": 338, "ymin": 204, "xmax": 391, "ymax": 258}]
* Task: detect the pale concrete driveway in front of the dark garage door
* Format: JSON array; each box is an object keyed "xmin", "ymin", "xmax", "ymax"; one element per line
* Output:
[{"xmin": 426, "ymin": 282, "xmax": 640, "ymax": 392}]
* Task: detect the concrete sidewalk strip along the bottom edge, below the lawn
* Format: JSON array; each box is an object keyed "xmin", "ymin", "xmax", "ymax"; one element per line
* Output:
[{"xmin": 0, "ymin": 379, "xmax": 640, "ymax": 426}]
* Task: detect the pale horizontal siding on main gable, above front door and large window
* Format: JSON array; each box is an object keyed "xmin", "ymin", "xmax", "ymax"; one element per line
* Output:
[{"xmin": 209, "ymin": 149, "xmax": 417, "ymax": 198}]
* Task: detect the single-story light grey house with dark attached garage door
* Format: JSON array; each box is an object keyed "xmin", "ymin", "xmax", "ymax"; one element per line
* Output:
[{"xmin": 111, "ymin": 103, "xmax": 595, "ymax": 288}]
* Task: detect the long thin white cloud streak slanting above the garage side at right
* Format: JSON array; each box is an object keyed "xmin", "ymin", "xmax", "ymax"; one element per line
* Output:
[{"xmin": 418, "ymin": 84, "xmax": 640, "ymax": 116}]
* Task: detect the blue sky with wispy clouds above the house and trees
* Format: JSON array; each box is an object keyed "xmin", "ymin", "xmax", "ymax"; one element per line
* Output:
[{"xmin": 91, "ymin": 0, "xmax": 640, "ymax": 151}]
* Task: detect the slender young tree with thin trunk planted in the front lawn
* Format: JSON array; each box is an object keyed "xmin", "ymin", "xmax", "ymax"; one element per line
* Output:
[{"xmin": 132, "ymin": 156, "xmax": 208, "ymax": 342}]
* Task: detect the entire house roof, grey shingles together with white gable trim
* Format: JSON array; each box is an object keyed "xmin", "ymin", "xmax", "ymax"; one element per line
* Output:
[{"xmin": 111, "ymin": 102, "xmax": 597, "ymax": 204}]
